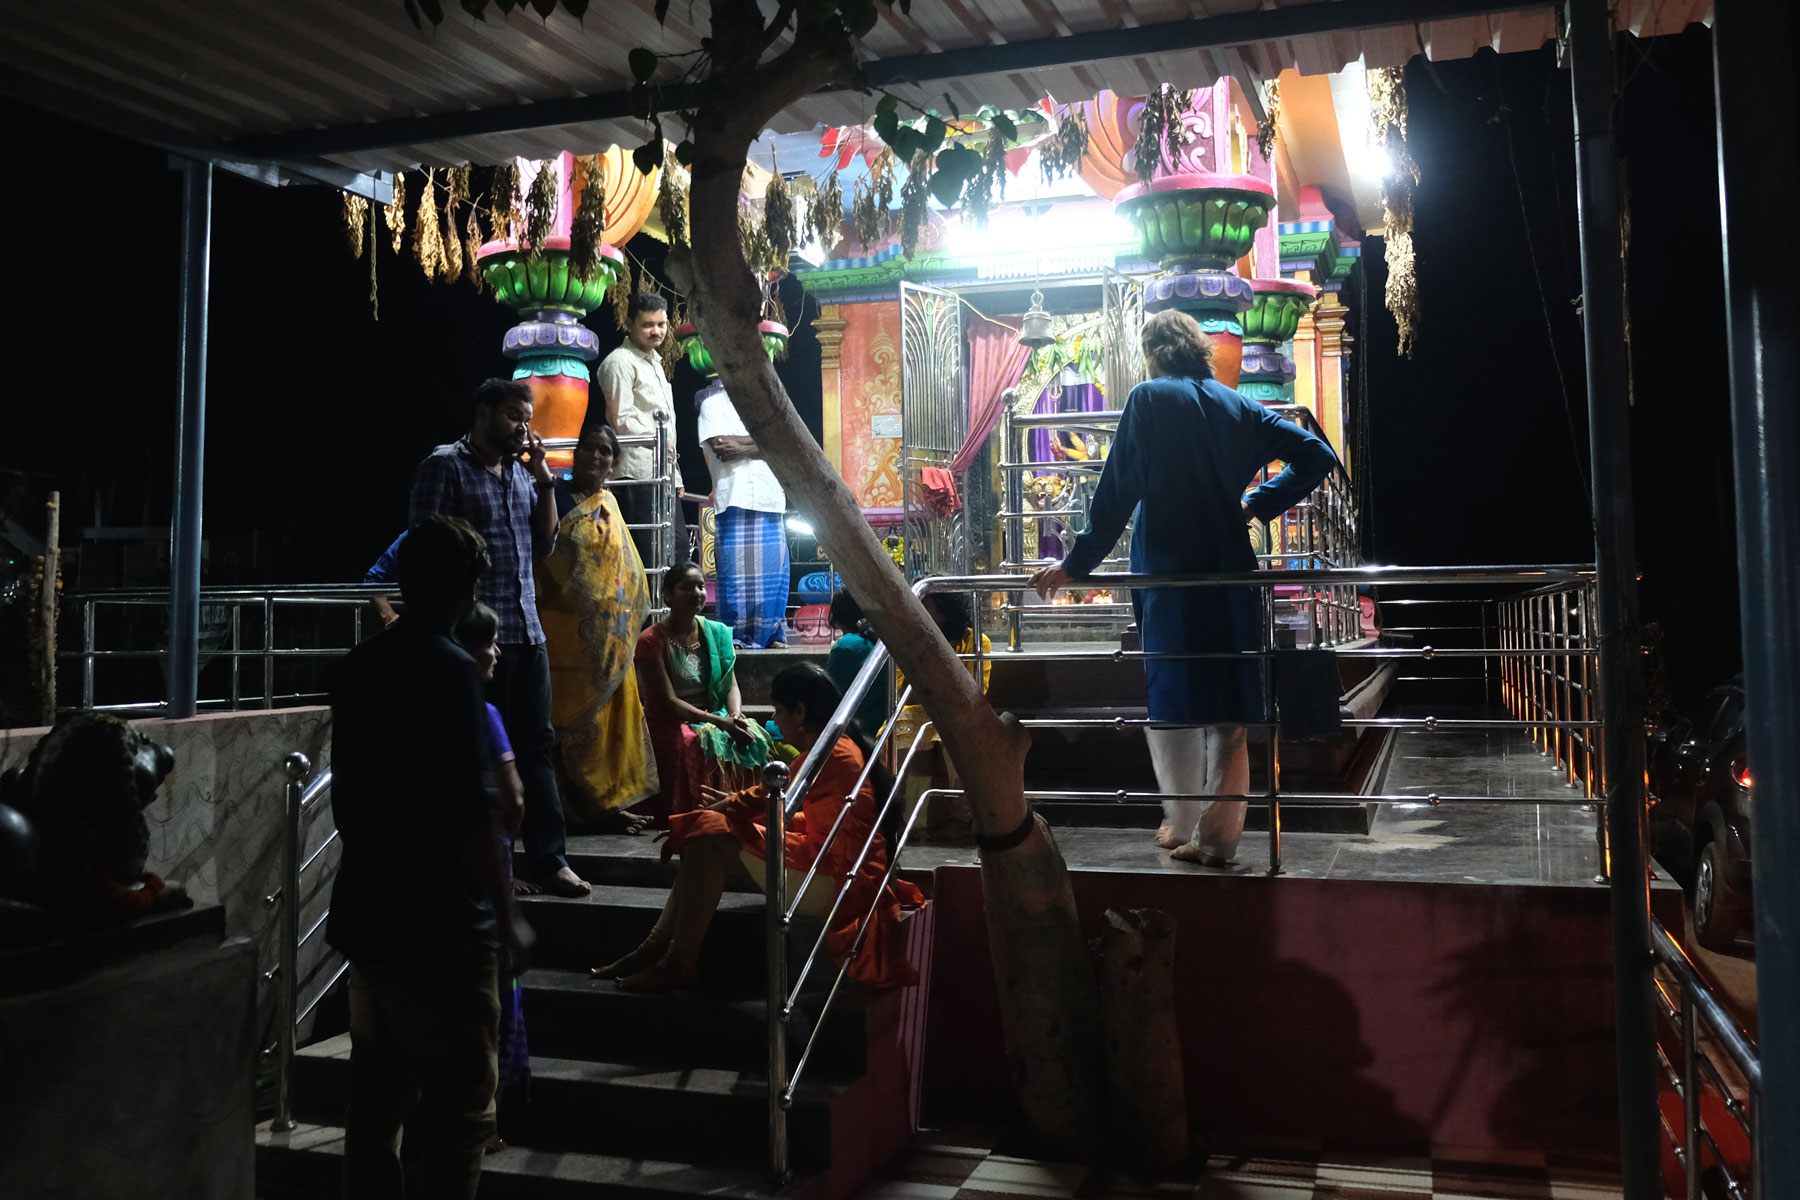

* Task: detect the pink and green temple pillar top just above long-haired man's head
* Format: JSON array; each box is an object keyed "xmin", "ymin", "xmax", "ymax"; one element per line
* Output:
[{"xmin": 1114, "ymin": 79, "xmax": 1274, "ymax": 387}]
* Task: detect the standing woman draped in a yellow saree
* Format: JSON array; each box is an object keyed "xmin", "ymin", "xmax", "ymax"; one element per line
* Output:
[{"xmin": 536, "ymin": 425, "xmax": 657, "ymax": 833}]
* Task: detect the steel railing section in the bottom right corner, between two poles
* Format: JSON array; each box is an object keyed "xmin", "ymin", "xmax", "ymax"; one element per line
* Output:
[{"xmin": 1651, "ymin": 918, "xmax": 1762, "ymax": 1200}]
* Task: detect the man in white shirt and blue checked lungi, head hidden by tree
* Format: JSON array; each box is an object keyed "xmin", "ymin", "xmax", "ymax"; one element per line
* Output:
[{"xmin": 695, "ymin": 380, "xmax": 790, "ymax": 649}]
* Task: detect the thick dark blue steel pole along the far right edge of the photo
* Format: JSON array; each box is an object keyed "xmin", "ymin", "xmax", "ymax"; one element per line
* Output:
[{"xmin": 1712, "ymin": 0, "xmax": 1800, "ymax": 1196}]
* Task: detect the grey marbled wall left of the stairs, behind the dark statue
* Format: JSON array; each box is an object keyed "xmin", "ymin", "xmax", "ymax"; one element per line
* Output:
[{"xmin": 0, "ymin": 707, "xmax": 338, "ymax": 1033}]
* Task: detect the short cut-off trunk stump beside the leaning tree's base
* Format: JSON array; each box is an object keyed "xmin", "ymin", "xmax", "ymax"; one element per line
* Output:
[{"xmin": 1094, "ymin": 909, "xmax": 1188, "ymax": 1168}]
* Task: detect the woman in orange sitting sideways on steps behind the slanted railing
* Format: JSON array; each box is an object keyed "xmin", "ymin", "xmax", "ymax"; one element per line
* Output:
[{"xmin": 594, "ymin": 666, "xmax": 925, "ymax": 991}]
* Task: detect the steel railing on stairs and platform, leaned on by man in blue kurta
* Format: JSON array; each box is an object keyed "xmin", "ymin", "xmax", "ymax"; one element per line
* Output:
[{"xmin": 765, "ymin": 565, "xmax": 1602, "ymax": 1178}]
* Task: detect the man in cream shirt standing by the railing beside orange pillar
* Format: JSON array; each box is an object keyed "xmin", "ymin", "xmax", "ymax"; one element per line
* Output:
[{"xmin": 594, "ymin": 291, "xmax": 688, "ymax": 572}]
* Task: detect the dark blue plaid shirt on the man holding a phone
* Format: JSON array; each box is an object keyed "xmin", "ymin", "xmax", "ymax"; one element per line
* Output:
[{"xmin": 407, "ymin": 437, "xmax": 556, "ymax": 646}]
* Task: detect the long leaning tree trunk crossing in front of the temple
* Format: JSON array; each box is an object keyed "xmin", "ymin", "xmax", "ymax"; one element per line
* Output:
[{"xmin": 670, "ymin": 0, "xmax": 1105, "ymax": 1155}]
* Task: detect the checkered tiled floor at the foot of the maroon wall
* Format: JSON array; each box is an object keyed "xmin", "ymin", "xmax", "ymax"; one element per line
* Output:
[{"xmin": 857, "ymin": 1130, "xmax": 1624, "ymax": 1200}]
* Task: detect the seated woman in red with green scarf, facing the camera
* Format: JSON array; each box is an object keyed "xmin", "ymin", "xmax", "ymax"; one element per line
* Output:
[{"xmin": 637, "ymin": 563, "xmax": 769, "ymax": 819}]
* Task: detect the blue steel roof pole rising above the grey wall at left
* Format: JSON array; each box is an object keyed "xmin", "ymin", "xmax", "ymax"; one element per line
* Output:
[{"xmin": 164, "ymin": 158, "xmax": 212, "ymax": 718}]
